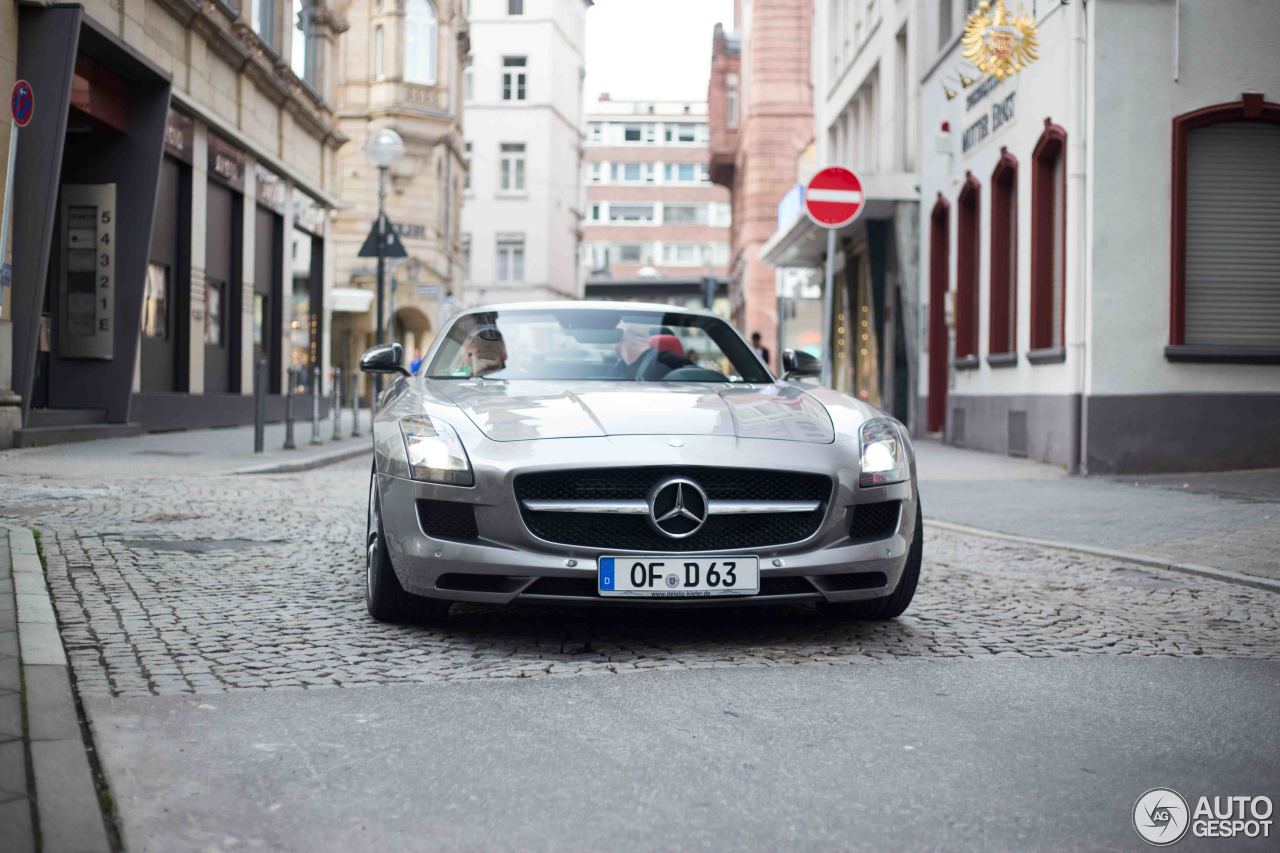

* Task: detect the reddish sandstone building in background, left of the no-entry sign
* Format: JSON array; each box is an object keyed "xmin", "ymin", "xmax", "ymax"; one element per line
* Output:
[{"xmin": 707, "ymin": 0, "xmax": 813, "ymax": 368}]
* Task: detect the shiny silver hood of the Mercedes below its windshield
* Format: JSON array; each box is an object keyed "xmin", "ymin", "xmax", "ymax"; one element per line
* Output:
[{"xmin": 436, "ymin": 379, "xmax": 836, "ymax": 444}]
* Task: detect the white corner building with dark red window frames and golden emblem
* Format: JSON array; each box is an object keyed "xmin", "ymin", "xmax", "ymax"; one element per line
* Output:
[{"xmin": 919, "ymin": 0, "xmax": 1280, "ymax": 473}]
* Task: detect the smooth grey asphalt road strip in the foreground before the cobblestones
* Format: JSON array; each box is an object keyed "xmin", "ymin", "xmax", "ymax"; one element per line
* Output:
[{"xmin": 88, "ymin": 657, "xmax": 1280, "ymax": 850}]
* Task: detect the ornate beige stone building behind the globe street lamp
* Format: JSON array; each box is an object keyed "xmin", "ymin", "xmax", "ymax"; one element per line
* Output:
[{"xmin": 332, "ymin": 0, "xmax": 468, "ymax": 371}]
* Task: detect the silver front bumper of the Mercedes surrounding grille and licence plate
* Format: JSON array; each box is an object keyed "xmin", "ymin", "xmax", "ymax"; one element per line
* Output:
[{"xmin": 378, "ymin": 437, "xmax": 916, "ymax": 607}]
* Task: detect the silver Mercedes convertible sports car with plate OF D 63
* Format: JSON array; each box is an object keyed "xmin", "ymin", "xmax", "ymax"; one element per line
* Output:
[{"xmin": 360, "ymin": 302, "xmax": 924, "ymax": 621}]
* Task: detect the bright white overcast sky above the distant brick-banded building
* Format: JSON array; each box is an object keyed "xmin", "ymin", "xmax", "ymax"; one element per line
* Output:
[{"xmin": 584, "ymin": 0, "xmax": 733, "ymax": 110}]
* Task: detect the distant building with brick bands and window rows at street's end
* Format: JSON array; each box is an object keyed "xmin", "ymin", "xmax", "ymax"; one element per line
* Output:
[{"xmin": 582, "ymin": 95, "xmax": 732, "ymax": 311}]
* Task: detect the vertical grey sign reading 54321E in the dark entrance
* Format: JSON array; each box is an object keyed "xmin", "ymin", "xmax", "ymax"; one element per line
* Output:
[{"xmin": 58, "ymin": 183, "xmax": 115, "ymax": 360}]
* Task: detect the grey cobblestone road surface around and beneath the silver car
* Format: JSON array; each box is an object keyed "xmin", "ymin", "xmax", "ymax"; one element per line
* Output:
[{"xmin": 0, "ymin": 461, "xmax": 1280, "ymax": 695}]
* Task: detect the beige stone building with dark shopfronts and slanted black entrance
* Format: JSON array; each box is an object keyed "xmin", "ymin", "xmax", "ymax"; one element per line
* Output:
[{"xmin": 0, "ymin": 0, "xmax": 347, "ymax": 446}]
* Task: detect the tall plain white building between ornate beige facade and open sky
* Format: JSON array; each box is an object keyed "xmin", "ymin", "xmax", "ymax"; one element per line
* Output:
[{"xmin": 462, "ymin": 0, "xmax": 591, "ymax": 305}]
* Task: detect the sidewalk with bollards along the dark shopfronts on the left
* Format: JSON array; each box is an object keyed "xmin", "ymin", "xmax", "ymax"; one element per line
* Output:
[{"xmin": 0, "ymin": 409, "xmax": 372, "ymax": 479}]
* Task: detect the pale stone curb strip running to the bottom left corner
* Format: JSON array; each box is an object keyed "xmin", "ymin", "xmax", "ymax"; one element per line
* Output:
[{"xmin": 0, "ymin": 526, "xmax": 111, "ymax": 853}]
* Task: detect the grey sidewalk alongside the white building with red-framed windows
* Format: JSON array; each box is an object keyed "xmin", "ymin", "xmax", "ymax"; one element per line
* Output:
[{"xmin": 915, "ymin": 441, "xmax": 1280, "ymax": 581}]
